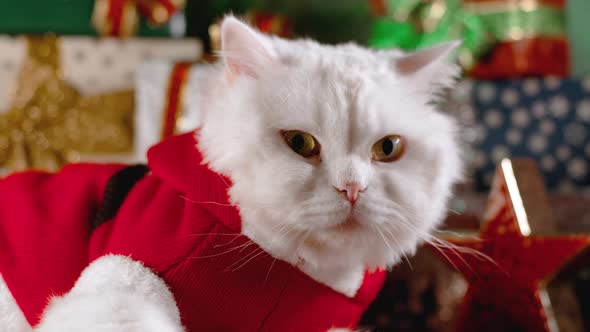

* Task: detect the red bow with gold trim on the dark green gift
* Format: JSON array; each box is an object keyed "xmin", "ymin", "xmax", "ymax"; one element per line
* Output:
[{"xmin": 92, "ymin": 0, "xmax": 185, "ymax": 37}]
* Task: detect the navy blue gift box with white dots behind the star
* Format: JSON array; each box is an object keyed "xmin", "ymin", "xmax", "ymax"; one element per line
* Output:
[{"xmin": 471, "ymin": 78, "xmax": 590, "ymax": 191}]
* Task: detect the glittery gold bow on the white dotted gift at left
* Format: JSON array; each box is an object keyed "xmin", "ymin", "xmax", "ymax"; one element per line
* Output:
[{"xmin": 0, "ymin": 35, "xmax": 133, "ymax": 171}]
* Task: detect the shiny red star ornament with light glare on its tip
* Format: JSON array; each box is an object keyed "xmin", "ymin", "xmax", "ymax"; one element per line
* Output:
[{"xmin": 436, "ymin": 159, "xmax": 590, "ymax": 332}]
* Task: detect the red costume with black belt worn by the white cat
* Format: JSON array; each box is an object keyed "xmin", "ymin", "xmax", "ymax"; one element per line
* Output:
[{"xmin": 0, "ymin": 134, "xmax": 384, "ymax": 332}]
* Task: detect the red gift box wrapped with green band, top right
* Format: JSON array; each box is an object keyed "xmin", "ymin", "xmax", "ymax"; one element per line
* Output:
[{"xmin": 465, "ymin": 0, "xmax": 571, "ymax": 79}]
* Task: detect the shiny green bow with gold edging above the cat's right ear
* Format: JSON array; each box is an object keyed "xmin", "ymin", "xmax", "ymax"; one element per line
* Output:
[{"xmin": 369, "ymin": 0, "xmax": 493, "ymax": 68}]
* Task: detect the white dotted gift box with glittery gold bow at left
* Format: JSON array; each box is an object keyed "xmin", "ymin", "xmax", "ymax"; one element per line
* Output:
[{"xmin": 0, "ymin": 35, "xmax": 201, "ymax": 174}]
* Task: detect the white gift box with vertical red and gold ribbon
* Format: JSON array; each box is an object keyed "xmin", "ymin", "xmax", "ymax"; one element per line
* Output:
[{"xmin": 135, "ymin": 60, "xmax": 211, "ymax": 160}]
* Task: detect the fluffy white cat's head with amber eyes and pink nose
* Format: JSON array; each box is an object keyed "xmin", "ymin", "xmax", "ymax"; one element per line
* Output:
[{"xmin": 199, "ymin": 18, "xmax": 461, "ymax": 267}]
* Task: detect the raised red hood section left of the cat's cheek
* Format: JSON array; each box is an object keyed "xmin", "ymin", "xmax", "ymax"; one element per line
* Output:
[{"xmin": 148, "ymin": 132, "xmax": 242, "ymax": 232}]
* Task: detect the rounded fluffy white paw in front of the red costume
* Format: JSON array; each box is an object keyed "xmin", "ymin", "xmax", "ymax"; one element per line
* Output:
[{"xmin": 35, "ymin": 255, "xmax": 183, "ymax": 332}]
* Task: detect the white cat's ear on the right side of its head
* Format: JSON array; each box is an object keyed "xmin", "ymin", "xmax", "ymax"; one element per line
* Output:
[{"xmin": 394, "ymin": 40, "xmax": 461, "ymax": 98}]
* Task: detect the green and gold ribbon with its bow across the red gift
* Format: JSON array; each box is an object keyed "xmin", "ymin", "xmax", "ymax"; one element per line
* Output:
[{"xmin": 369, "ymin": 0, "xmax": 565, "ymax": 69}]
